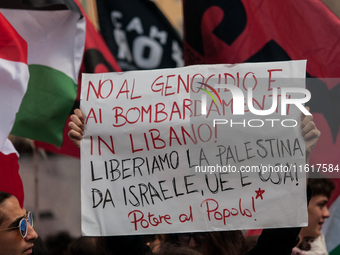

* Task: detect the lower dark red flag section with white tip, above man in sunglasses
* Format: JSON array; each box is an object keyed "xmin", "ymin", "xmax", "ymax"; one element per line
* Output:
[{"xmin": 0, "ymin": 139, "xmax": 24, "ymax": 207}]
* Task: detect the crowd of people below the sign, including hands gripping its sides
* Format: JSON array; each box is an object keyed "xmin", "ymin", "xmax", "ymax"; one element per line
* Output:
[{"xmin": 0, "ymin": 109, "xmax": 335, "ymax": 255}]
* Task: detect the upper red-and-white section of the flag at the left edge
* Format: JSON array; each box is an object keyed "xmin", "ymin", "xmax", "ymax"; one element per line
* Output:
[{"xmin": 0, "ymin": 13, "xmax": 29, "ymax": 151}]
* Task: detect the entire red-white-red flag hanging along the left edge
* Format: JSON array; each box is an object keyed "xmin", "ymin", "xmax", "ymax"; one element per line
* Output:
[{"xmin": 0, "ymin": 13, "xmax": 29, "ymax": 207}]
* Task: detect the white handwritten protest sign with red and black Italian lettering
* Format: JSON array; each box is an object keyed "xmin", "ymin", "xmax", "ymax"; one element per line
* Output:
[{"xmin": 81, "ymin": 61, "xmax": 307, "ymax": 236}]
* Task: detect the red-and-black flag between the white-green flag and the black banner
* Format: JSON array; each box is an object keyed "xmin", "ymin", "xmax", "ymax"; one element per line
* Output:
[{"xmin": 34, "ymin": 0, "xmax": 121, "ymax": 158}]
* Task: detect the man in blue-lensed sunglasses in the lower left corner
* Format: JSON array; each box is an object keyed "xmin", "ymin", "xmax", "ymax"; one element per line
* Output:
[{"xmin": 0, "ymin": 191, "xmax": 38, "ymax": 255}]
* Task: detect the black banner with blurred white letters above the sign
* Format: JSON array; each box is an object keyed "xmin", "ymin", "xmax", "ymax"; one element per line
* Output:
[{"xmin": 97, "ymin": 0, "xmax": 184, "ymax": 71}]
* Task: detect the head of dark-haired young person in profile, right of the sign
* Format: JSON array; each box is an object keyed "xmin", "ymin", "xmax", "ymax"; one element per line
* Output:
[{"xmin": 299, "ymin": 178, "xmax": 335, "ymax": 239}]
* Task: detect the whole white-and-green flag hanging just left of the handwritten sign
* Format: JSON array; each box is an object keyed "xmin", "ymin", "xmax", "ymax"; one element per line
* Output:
[{"xmin": 0, "ymin": 4, "xmax": 85, "ymax": 146}]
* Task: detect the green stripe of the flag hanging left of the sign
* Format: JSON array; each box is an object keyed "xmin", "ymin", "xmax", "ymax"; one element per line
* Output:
[{"xmin": 11, "ymin": 65, "xmax": 77, "ymax": 146}]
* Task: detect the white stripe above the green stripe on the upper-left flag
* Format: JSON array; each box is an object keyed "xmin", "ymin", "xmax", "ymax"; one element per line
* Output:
[{"xmin": 0, "ymin": 9, "xmax": 85, "ymax": 84}]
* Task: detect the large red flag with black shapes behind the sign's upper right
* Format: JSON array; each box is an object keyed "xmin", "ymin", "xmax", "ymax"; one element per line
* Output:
[{"xmin": 184, "ymin": 0, "xmax": 340, "ymax": 171}]
